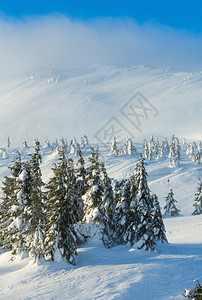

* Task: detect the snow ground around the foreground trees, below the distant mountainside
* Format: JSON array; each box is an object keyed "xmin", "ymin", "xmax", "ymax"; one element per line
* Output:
[{"xmin": 0, "ymin": 141, "xmax": 202, "ymax": 300}]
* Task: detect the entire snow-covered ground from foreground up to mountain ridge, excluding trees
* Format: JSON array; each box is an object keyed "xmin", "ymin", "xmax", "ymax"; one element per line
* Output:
[{"xmin": 0, "ymin": 66, "xmax": 202, "ymax": 300}]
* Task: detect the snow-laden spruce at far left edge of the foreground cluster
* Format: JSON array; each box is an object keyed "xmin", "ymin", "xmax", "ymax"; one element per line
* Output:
[{"xmin": 0, "ymin": 152, "xmax": 22, "ymax": 254}]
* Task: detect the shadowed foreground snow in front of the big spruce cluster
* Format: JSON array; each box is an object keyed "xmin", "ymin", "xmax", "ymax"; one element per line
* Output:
[{"xmin": 0, "ymin": 216, "xmax": 202, "ymax": 300}]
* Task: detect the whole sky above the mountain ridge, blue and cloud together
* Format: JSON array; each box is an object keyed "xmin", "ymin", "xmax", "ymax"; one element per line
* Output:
[{"xmin": 0, "ymin": 0, "xmax": 202, "ymax": 76}]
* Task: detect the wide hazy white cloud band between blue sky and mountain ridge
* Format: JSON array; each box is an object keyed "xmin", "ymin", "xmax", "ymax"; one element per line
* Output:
[{"xmin": 0, "ymin": 15, "xmax": 202, "ymax": 75}]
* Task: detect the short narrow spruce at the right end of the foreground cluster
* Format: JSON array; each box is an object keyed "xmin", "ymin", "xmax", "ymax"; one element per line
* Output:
[{"xmin": 152, "ymin": 194, "xmax": 168, "ymax": 243}]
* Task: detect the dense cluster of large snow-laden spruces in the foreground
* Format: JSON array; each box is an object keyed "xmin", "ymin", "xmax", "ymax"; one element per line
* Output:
[{"xmin": 0, "ymin": 141, "xmax": 200, "ymax": 264}]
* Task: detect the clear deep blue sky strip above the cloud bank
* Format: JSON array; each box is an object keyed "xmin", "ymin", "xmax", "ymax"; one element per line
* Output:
[{"xmin": 0, "ymin": 0, "xmax": 202, "ymax": 33}]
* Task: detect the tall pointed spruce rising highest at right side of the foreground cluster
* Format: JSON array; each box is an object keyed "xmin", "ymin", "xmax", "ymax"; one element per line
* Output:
[{"xmin": 135, "ymin": 156, "xmax": 156, "ymax": 251}]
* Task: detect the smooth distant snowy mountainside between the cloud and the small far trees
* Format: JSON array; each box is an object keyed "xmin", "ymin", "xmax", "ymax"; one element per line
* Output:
[{"xmin": 0, "ymin": 66, "xmax": 202, "ymax": 146}]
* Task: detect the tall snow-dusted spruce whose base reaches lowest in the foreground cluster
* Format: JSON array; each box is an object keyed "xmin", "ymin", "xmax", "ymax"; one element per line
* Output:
[{"xmin": 45, "ymin": 151, "xmax": 79, "ymax": 264}]
